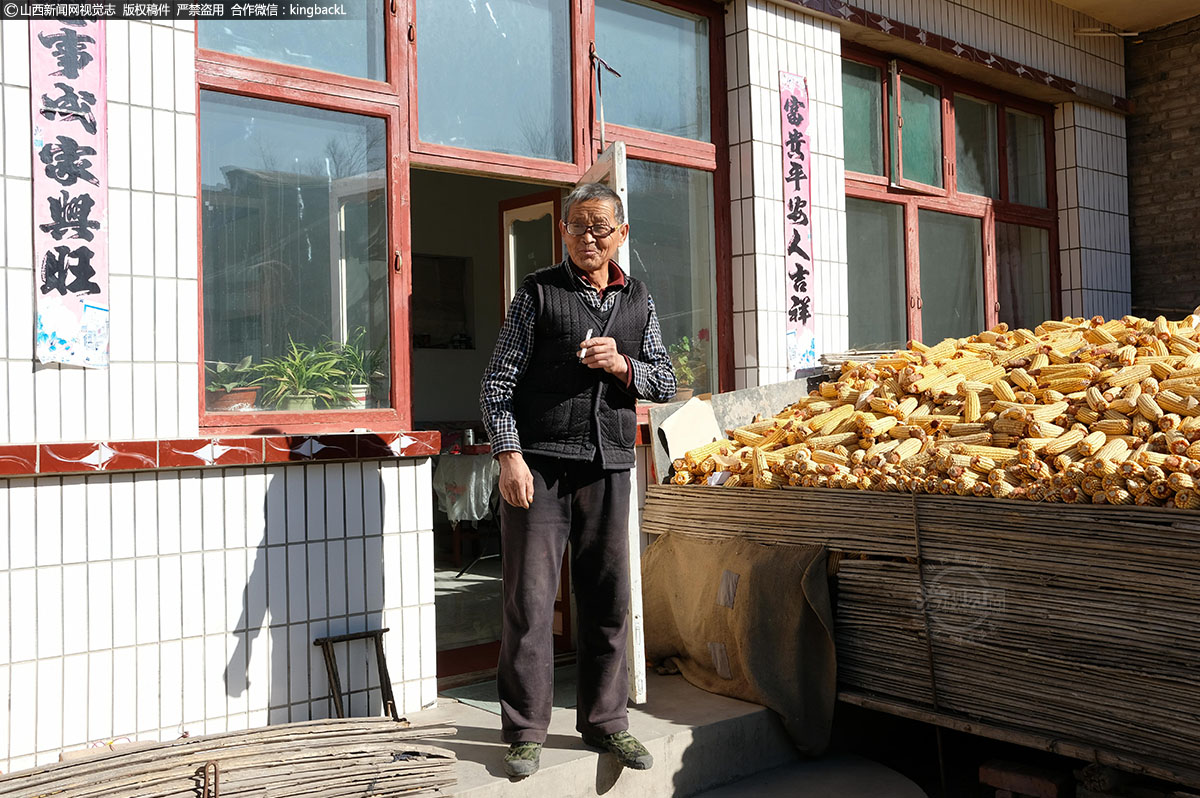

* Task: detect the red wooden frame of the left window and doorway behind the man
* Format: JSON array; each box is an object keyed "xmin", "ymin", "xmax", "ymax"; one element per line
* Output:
[{"xmin": 196, "ymin": 0, "xmax": 733, "ymax": 433}]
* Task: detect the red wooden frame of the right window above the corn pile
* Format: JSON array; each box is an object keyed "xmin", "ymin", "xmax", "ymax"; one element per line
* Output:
[{"xmin": 841, "ymin": 43, "xmax": 1062, "ymax": 341}]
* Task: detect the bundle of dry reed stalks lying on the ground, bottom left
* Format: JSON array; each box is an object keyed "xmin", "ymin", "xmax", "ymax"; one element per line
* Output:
[{"xmin": 0, "ymin": 718, "xmax": 456, "ymax": 798}]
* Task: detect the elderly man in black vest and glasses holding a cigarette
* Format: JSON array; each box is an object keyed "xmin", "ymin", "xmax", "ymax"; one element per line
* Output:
[{"xmin": 480, "ymin": 184, "xmax": 676, "ymax": 776}]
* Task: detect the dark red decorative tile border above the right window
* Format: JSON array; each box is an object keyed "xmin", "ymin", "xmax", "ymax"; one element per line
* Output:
[{"xmin": 781, "ymin": 0, "xmax": 1133, "ymax": 114}]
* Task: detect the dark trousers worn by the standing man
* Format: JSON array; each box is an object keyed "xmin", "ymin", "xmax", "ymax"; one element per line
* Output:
[{"xmin": 497, "ymin": 455, "xmax": 630, "ymax": 743}]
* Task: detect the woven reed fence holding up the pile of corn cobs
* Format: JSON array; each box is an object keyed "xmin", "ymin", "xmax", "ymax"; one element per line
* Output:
[{"xmin": 642, "ymin": 485, "xmax": 1200, "ymax": 787}]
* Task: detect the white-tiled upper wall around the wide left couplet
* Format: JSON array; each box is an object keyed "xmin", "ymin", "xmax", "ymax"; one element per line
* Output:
[{"xmin": 0, "ymin": 22, "xmax": 199, "ymax": 443}]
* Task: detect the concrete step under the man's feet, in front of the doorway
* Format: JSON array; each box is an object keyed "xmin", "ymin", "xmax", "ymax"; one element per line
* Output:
[{"xmin": 409, "ymin": 673, "xmax": 806, "ymax": 798}]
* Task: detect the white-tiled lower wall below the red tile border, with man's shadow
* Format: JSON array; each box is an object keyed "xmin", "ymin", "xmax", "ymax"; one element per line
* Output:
[{"xmin": 0, "ymin": 460, "xmax": 437, "ymax": 772}]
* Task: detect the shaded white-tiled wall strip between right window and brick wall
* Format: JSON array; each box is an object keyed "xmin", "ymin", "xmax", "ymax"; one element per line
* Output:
[{"xmin": 1055, "ymin": 103, "xmax": 1132, "ymax": 318}]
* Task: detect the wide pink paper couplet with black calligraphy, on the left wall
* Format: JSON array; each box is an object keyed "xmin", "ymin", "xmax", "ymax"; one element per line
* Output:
[{"xmin": 29, "ymin": 20, "xmax": 108, "ymax": 367}]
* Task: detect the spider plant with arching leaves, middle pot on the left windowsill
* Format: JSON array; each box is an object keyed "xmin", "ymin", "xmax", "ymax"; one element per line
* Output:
[{"xmin": 258, "ymin": 336, "xmax": 350, "ymax": 410}]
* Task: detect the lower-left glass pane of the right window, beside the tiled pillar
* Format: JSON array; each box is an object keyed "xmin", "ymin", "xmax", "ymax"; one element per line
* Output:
[{"xmin": 846, "ymin": 197, "xmax": 908, "ymax": 349}]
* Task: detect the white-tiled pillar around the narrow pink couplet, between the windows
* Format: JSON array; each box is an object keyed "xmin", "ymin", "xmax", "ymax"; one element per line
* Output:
[{"xmin": 726, "ymin": 0, "xmax": 848, "ymax": 388}]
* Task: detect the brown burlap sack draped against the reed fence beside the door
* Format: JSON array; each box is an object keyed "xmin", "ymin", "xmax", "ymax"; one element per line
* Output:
[{"xmin": 642, "ymin": 534, "xmax": 838, "ymax": 755}]
